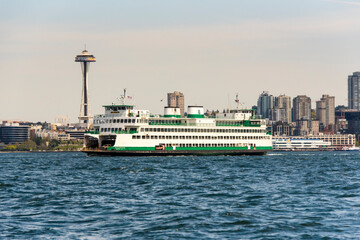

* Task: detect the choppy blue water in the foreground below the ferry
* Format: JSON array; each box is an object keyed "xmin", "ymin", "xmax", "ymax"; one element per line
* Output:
[{"xmin": 0, "ymin": 152, "xmax": 360, "ymax": 239}]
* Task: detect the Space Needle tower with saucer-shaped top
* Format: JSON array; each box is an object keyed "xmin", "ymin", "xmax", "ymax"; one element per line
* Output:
[{"xmin": 75, "ymin": 47, "xmax": 96, "ymax": 128}]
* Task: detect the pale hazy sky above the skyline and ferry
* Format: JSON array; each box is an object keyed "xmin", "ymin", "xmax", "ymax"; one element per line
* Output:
[{"xmin": 0, "ymin": 0, "xmax": 360, "ymax": 122}]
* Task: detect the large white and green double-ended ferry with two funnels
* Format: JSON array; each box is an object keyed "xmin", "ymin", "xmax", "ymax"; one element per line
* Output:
[{"xmin": 83, "ymin": 94, "xmax": 272, "ymax": 156}]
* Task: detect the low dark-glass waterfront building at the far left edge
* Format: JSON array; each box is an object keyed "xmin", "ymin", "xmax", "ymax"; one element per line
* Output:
[{"xmin": 0, "ymin": 121, "xmax": 30, "ymax": 144}]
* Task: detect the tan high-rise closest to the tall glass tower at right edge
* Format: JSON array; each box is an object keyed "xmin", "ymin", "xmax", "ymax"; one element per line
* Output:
[{"xmin": 316, "ymin": 95, "xmax": 335, "ymax": 130}]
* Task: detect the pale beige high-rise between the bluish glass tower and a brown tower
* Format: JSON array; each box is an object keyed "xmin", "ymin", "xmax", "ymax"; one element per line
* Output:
[{"xmin": 272, "ymin": 95, "xmax": 291, "ymax": 123}]
